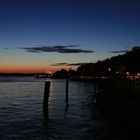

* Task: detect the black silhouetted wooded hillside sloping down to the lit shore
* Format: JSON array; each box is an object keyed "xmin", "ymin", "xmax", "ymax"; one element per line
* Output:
[{"xmin": 53, "ymin": 47, "xmax": 140, "ymax": 78}]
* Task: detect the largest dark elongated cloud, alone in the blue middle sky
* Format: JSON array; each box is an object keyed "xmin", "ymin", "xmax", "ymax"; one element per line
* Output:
[{"xmin": 21, "ymin": 45, "xmax": 94, "ymax": 53}]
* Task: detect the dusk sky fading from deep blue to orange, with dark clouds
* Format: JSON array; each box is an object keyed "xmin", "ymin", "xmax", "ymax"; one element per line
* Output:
[{"xmin": 0, "ymin": 0, "xmax": 140, "ymax": 73}]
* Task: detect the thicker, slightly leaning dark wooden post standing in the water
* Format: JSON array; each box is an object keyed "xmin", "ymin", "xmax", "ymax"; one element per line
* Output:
[{"xmin": 43, "ymin": 81, "xmax": 51, "ymax": 118}]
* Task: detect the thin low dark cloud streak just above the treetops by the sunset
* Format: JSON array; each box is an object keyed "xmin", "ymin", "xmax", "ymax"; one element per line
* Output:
[{"xmin": 50, "ymin": 62, "xmax": 90, "ymax": 66}]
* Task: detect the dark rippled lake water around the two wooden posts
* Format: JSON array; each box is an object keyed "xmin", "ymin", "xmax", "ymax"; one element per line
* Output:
[{"xmin": 0, "ymin": 77, "xmax": 129, "ymax": 140}]
